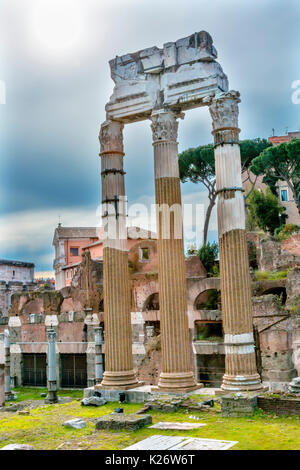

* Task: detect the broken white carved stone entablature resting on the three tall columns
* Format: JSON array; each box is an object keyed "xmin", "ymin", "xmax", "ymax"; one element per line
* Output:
[{"xmin": 106, "ymin": 31, "xmax": 228, "ymax": 123}]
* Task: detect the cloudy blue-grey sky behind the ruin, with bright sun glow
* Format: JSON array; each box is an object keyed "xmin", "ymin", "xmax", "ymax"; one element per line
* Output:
[{"xmin": 0, "ymin": 0, "xmax": 300, "ymax": 271}]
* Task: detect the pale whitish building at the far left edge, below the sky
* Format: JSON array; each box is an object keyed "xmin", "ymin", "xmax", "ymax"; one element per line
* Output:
[{"xmin": 0, "ymin": 260, "xmax": 35, "ymax": 318}]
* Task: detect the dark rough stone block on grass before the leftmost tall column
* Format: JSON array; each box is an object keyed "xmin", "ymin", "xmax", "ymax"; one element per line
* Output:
[{"xmin": 96, "ymin": 413, "xmax": 152, "ymax": 431}]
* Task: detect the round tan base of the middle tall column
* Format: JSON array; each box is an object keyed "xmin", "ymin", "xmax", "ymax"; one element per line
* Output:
[{"xmin": 153, "ymin": 372, "xmax": 199, "ymax": 393}]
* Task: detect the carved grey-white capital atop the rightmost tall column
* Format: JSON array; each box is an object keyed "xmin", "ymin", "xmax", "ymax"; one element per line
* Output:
[{"xmin": 206, "ymin": 90, "xmax": 241, "ymax": 131}]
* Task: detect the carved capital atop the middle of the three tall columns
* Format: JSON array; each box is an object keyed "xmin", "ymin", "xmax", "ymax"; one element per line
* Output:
[{"xmin": 151, "ymin": 110, "xmax": 183, "ymax": 142}]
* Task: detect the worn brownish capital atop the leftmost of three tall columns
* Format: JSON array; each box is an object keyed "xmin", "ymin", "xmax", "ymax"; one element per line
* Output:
[{"xmin": 99, "ymin": 120, "xmax": 124, "ymax": 153}]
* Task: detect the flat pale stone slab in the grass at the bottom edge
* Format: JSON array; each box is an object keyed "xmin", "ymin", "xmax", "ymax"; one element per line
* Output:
[{"xmin": 124, "ymin": 434, "xmax": 237, "ymax": 450}]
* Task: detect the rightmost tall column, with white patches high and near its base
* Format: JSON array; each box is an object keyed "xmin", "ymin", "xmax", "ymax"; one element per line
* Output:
[{"xmin": 209, "ymin": 92, "xmax": 262, "ymax": 391}]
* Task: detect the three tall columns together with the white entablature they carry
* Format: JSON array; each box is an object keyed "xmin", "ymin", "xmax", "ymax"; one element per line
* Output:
[{"xmin": 99, "ymin": 31, "xmax": 261, "ymax": 391}]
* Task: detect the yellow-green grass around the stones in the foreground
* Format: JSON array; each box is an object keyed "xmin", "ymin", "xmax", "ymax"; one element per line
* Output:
[{"xmin": 0, "ymin": 388, "xmax": 300, "ymax": 450}]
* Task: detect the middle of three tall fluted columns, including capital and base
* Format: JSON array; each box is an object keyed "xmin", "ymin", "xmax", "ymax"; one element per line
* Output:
[{"xmin": 151, "ymin": 110, "xmax": 197, "ymax": 391}]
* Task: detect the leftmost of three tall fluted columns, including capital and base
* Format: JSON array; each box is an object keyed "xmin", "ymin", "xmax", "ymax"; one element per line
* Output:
[{"xmin": 99, "ymin": 121, "xmax": 137, "ymax": 389}]
